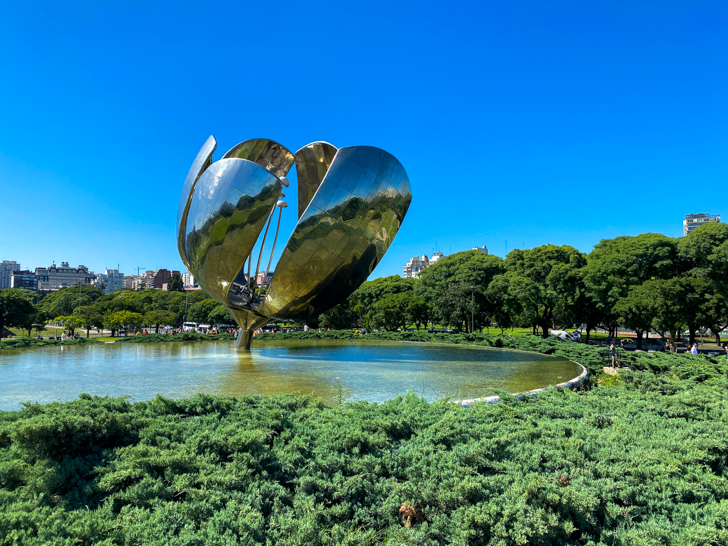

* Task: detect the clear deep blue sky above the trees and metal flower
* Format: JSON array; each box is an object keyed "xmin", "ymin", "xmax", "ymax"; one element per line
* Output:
[{"xmin": 0, "ymin": 0, "xmax": 728, "ymax": 277}]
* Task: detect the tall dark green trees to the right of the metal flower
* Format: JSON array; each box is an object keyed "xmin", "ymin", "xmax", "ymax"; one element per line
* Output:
[{"xmin": 319, "ymin": 223, "xmax": 728, "ymax": 348}]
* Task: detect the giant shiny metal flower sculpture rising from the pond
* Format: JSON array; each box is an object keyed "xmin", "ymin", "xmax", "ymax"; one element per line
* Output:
[{"xmin": 177, "ymin": 136, "xmax": 412, "ymax": 349}]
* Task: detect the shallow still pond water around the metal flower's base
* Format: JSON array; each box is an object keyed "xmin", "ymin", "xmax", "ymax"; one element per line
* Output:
[{"xmin": 0, "ymin": 340, "xmax": 580, "ymax": 410}]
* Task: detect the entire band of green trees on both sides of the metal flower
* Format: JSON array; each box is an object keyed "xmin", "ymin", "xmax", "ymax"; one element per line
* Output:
[{"xmin": 0, "ymin": 223, "xmax": 728, "ymax": 348}]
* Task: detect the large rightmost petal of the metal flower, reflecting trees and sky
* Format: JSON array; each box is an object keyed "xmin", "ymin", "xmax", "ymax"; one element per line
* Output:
[{"xmin": 258, "ymin": 146, "xmax": 412, "ymax": 319}]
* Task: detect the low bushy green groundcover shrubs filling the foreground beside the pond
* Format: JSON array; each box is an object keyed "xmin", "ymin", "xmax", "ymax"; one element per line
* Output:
[{"xmin": 0, "ymin": 336, "xmax": 728, "ymax": 546}]
